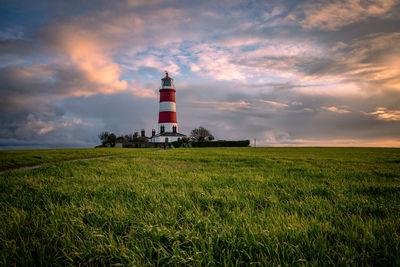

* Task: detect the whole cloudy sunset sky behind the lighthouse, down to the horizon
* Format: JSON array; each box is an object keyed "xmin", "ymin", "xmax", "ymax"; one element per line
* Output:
[{"xmin": 0, "ymin": 0, "xmax": 400, "ymax": 149}]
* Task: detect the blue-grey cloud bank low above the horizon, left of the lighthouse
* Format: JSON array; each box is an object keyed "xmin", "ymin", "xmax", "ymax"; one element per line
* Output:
[{"xmin": 0, "ymin": 92, "xmax": 158, "ymax": 147}]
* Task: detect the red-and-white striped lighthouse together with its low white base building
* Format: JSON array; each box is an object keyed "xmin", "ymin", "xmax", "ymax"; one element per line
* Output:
[{"xmin": 150, "ymin": 72, "xmax": 185, "ymax": 143}]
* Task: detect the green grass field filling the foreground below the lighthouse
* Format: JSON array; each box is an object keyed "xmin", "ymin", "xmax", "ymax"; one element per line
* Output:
[{"xmin": 0, "ymin": 148, "xmax": 400, "ymax": 266}]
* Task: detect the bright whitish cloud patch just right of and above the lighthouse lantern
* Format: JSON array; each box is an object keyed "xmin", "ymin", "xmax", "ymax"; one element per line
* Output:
[{"xmin": 188, "ymin": 39, "xmax": 324, "ymax": 82}]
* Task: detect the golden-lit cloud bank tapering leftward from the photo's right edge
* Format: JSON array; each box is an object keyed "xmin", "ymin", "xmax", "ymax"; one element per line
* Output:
[{"xmin": 232, "ymin": 32, "xmax": 400, "ymax": 96}]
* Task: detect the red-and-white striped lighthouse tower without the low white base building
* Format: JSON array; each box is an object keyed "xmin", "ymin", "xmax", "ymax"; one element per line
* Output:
[{"xmin": 158, "ymin": 72, "xmax": 178, "ymax": 133}]
